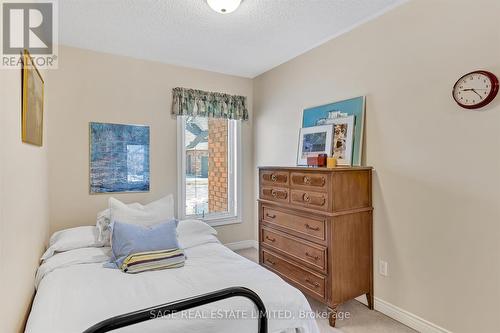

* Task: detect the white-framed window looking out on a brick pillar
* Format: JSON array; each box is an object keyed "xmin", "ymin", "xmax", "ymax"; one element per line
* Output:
[{"xmin": 177, "ymin": 116, "xmax": 241, "ymax": 225}]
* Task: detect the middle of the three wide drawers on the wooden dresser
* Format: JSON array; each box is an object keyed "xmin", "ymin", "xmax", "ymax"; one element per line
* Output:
[{"xmin": 261, "ymin": 227, "xmax": 327, "ymax": 273}]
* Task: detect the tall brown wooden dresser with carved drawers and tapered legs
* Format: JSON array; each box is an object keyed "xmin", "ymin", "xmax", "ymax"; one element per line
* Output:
[{"xmin": 259, "ymin": 167, "xmax": 373, "ymax": 326}]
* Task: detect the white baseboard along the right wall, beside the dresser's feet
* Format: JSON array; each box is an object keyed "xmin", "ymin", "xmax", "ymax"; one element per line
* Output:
[{"xmin": 356, "ymin": 296, "xmax": 452, "ymax": 333}]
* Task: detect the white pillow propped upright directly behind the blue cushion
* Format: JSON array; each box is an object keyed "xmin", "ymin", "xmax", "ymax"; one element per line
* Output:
[{"xmin": 109, "ymin": 194, "xmax": 175, "ymax": 226}]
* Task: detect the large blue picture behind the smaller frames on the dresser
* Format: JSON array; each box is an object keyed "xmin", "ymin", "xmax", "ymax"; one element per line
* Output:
[{"xmin": 302, "ymin": 96, "xmax": 365, "ymax": 165}]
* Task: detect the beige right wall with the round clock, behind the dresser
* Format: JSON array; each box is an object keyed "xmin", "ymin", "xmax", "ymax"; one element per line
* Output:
[{"xmin": 254, "ymin": 0, "xmax": 500, "ymax": 333}]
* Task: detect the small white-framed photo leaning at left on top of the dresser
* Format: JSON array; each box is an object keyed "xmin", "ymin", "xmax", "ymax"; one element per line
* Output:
[{"xmin": 297, "ymin": 125, "xmax": 333, "ymax": 165}]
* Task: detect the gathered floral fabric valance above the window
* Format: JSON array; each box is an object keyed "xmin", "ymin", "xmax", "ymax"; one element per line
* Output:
[{"xmin": 172, "ymin": 88, "xmax": 248, "ymax": 120}]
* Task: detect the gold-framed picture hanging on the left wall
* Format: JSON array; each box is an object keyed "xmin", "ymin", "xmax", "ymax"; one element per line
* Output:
[{"xmin": 21, "ymin": 50, "xmax": 44, "ymax": 147}]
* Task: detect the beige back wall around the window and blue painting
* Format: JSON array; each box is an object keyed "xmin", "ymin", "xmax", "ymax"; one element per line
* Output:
[{"xmin": 48, "ymin": 47, "xmax": 254, "ymax": 243}]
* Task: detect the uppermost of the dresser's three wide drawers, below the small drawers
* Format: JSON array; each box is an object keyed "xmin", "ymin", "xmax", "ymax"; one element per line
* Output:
[{"xmin": 261, "ymin": 205, "xmax": 326, "ymax": 241}]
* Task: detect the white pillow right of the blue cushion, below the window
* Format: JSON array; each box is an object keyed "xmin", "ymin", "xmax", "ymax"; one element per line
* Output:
[{"xmin": 177, "ymin": 220, "xmax": 220, "ymax": 249}]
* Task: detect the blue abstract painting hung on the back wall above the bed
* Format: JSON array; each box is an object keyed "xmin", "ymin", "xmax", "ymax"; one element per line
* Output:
[{"xmin": 90, "ymin": 123, "xmax": 149, "ymax": 194}]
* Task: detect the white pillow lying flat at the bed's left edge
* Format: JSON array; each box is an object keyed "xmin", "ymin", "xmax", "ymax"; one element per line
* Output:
[{"xmin": 41, "ymin": 226, "xmax": 103, "ymax": 260}]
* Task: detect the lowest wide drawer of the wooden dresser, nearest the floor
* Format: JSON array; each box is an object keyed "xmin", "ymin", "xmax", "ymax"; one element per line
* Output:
[{"xmin": 262, "ymin": 249, "xmax": 325, "ymax": 299}]
